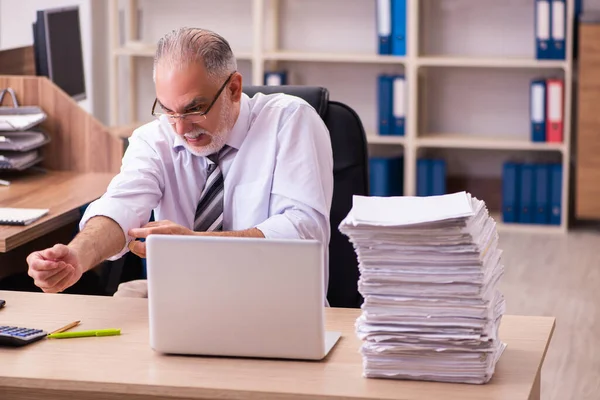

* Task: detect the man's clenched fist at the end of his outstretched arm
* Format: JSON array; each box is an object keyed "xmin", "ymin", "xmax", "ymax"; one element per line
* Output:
[{"xmin": 27, "ymin": 244, "xmax": 83, "ymax": 293}]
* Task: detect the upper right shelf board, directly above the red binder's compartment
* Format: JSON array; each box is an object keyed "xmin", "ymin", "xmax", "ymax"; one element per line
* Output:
[{"xmin": 417, "ymin": 56, "xmax": 568, "ymax": 69}]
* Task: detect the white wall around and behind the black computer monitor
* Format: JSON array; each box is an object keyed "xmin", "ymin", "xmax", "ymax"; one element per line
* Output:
[{"xmin": 0, "ymin": 0, "xmax": 94, "ymax": 112}]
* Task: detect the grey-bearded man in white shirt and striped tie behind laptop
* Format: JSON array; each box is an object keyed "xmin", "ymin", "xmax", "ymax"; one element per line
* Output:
[{"xmin": 27, "ymin": 28, "xmax": 333, "ymax": 292}]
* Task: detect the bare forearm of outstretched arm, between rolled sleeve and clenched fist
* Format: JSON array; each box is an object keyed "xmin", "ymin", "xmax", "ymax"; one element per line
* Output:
[{"xmin": 69, "ymin": 216, "xmax": 125, "ymax": 271}]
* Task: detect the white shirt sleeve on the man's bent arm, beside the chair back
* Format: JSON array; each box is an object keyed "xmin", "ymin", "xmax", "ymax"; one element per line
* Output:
[{"xmin": 257, "ymin": 105, "xmax": 333, "ymax": 246}]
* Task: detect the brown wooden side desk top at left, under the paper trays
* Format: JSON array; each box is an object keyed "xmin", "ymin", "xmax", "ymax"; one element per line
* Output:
[{"xmin": 0, "ymin": 171, "xmax": 114, "ymax": 253}]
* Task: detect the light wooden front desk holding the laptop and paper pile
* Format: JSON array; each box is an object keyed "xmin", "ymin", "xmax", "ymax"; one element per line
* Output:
[{"xmin": 0, "ymin": 291, "xmax": 554, "ymax": 400}]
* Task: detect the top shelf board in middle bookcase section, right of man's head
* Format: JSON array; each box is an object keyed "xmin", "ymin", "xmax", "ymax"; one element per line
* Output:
[{"xmin": 263, "ymin": 51, "xmax": 406, "ymax": 64}]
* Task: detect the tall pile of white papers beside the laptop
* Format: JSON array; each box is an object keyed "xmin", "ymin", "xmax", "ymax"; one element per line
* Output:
[{"xmin": 339, "ymin": 192, "xmax": 506, "ymax": 384}]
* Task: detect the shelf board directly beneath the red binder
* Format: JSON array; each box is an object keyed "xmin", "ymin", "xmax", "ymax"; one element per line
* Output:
[{"xmin": 416, "ymin": 133, "xmax": 565, "ymax": 152}]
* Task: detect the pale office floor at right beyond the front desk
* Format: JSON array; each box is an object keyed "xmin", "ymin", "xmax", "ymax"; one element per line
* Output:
[{"xmin": 500, "ymin": 230, "xmax": 600, "ymax": 400}]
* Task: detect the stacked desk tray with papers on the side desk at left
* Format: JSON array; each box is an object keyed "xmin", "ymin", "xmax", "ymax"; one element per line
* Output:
[{"xmin": 0, "ymin": 88, "xmax": 50, "ymax": 171}]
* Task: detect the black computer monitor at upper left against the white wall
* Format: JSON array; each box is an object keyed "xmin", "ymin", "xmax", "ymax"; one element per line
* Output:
[{"xmin": 33, "ymin": 6, "xmax": 87, "ymax": 100}]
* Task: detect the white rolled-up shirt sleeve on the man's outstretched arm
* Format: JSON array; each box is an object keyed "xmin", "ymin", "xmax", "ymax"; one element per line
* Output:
[{"xmin": 79, "ymin": 131, "xmax": 164, "ymax": 260}]
